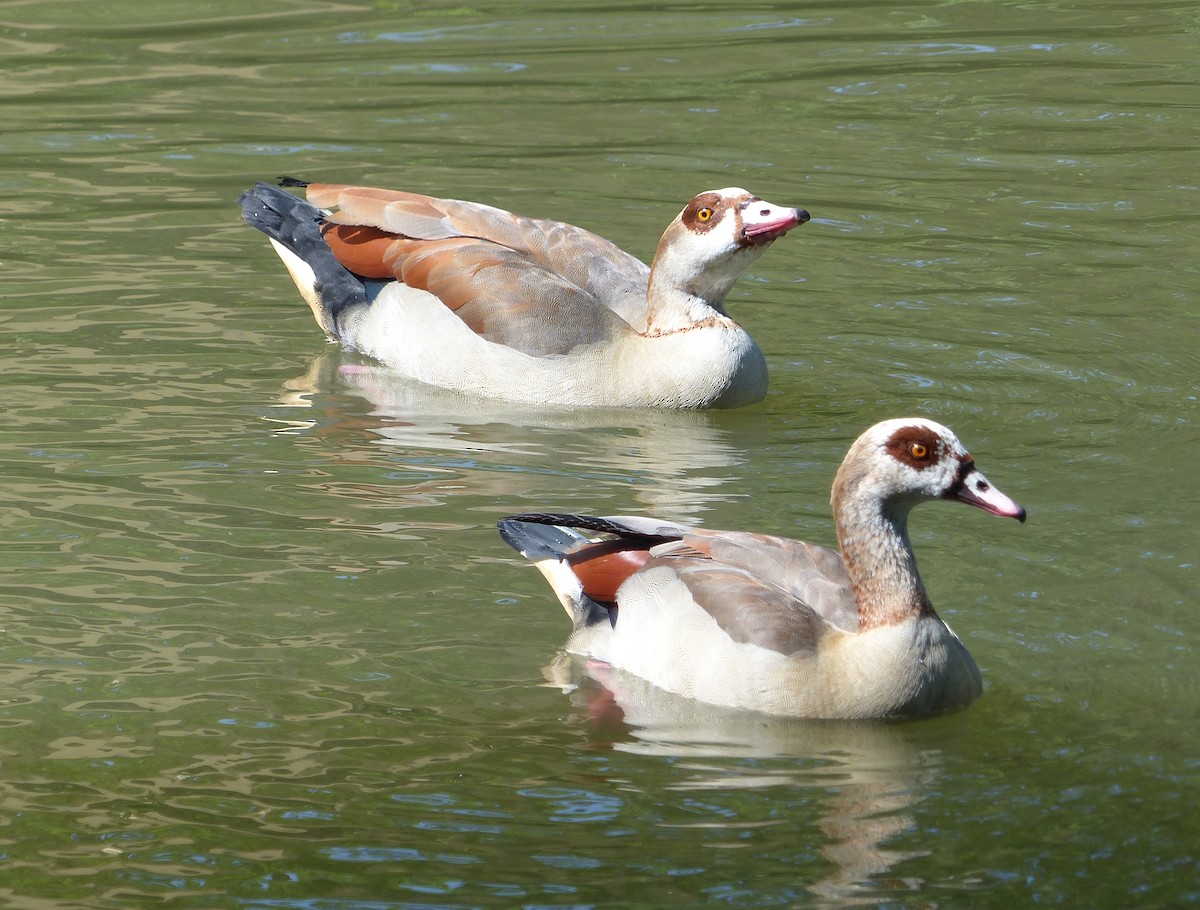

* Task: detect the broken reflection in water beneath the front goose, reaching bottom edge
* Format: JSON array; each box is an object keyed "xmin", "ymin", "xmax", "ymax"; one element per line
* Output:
[{"xmin": 544, "ymin": 652, "xmax": 966, "ymax": 906}]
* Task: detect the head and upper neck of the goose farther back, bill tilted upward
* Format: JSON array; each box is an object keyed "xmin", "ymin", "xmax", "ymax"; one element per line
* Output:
[{"xmin": 650, "ymin": 186, "xmax": 809, "ymax": 312}]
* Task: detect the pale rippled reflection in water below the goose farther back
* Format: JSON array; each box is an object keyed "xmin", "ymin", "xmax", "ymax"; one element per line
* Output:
[{"xmin": 271, "ymin": 348, "xmax": 749, "ymax": 517}]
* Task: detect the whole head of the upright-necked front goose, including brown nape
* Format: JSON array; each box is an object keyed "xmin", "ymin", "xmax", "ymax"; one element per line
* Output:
[{"xmin": 833, "ymin": 417, "xmax": 1025, "ymax": 528}]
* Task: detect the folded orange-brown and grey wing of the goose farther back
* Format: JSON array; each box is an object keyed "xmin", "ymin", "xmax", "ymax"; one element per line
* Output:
[{"xmin": 307, "ymin": 184, "xmax": 649, "ymax": 355}]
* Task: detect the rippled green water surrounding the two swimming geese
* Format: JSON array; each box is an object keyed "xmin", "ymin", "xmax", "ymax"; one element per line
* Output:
[{"xmin": 0, "ymin": 0, "xmax": 1200, "ymax": 910}]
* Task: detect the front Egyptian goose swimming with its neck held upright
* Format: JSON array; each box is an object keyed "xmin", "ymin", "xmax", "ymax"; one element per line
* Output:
[{"xmin": 499, "ymin": 418, "xmax": 1025, "ymax": 718}]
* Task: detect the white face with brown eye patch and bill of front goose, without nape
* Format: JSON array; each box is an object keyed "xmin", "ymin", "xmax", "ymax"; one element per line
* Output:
[{"xmin": 851, "ymin": 418, "xmax": 1025, "ymax": 521}]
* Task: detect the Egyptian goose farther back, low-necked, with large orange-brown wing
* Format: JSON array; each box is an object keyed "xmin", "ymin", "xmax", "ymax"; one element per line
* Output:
[{"xmin": 240, "ymin": 178, "xmax": 809, "ymax": 408}]
